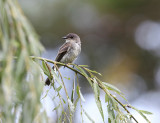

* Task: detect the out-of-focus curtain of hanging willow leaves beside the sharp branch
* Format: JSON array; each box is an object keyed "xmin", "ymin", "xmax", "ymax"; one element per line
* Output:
[{"xmin": 0, "ymin": 0, "xmax": 47, "ymax": 123}]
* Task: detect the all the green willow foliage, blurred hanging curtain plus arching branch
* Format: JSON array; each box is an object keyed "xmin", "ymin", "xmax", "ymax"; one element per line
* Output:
[{"xmin": 0, "ymin": 0, "xmax": 151, "ymax": 123}]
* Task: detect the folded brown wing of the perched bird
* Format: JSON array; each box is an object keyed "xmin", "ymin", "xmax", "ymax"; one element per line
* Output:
[{"xmin": 55, "ymin": 42, "xmax": 71, "ymax": 62}]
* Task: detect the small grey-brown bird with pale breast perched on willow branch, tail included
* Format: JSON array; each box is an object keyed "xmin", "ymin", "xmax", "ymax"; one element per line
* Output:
[{"xmin": 45, "ymin": 33, "xmax": 81, "ymax": 85}]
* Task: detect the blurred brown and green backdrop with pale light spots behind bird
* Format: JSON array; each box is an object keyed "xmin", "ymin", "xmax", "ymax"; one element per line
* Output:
[{"xmin": 19, "ymin": 0, "xmax": 160, "ymax": 123}]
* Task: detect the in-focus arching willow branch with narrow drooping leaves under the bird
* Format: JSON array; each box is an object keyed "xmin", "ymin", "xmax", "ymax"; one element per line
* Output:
[{"xmin": 35, "ymin": 57, "xmax": 152, "ymax": 123}]
